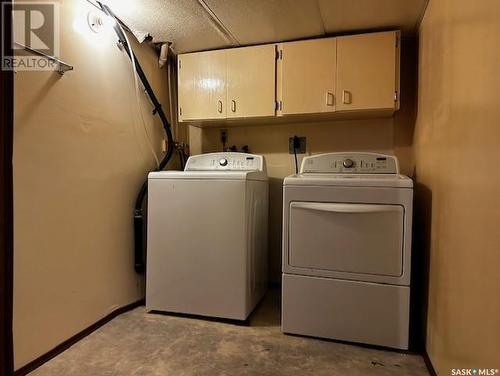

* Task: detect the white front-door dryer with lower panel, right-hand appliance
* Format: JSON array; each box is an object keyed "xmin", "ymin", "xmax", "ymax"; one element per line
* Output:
[{"xmin": 282, "ymin": 153, "xmax": 413, "ymax": 349}]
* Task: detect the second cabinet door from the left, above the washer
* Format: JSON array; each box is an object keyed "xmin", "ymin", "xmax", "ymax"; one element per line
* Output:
[{"xmin": 226, "ymin": 45, "xmax": 276, "ymax": 118}]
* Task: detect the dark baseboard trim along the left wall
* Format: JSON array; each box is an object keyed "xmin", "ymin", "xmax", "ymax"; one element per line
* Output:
[{"xmin": 14, "ymin": 299, "xmax": 144, "ymax": 376}]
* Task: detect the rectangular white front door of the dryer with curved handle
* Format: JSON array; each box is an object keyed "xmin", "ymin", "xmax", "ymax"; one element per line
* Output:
[{"xmin": 288, "ymin": 202, "xmax": 404, "ymax": 276}]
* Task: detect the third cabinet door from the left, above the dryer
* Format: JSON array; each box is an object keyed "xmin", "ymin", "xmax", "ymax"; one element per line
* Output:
[{"xmin": 278, "ymin": 38, "xmax": 336, "ymax": 115}]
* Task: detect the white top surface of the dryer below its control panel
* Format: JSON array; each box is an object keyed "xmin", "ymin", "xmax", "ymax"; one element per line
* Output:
[{"xmin": 283, "ymin": 173, "xmax": 413, "ymax": 188}]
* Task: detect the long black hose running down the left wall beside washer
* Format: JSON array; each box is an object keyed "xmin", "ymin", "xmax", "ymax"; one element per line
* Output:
[{"xmin": 97, "ymin": 1, "xmax": 175, "ymax": 273}]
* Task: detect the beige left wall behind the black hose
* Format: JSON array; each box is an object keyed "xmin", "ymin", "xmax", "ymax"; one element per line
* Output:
[{"xmin": 14, "ymin": 1, "xmax": 172, "ymax": 368}]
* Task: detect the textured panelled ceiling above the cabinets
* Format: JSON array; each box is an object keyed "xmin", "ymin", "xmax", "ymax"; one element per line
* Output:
[{"xmin": 106, "ymin": 0, "xmax": 428, "ymax": 53}]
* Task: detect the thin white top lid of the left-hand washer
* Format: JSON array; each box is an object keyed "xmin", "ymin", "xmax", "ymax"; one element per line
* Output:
[{"xmin": 148, "ymin": 171, "xmax": 267, "ymax": 181}]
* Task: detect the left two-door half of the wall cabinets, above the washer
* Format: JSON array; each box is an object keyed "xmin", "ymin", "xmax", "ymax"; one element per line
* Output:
[{"xmin": 178, "ymin": 45, "xmax": 276, "ymax": 121}]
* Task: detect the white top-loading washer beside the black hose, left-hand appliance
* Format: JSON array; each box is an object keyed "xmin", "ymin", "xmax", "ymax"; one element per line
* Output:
[{"xmin": 146, "ymin": 153, "xmax": 268, "ymax": 320}]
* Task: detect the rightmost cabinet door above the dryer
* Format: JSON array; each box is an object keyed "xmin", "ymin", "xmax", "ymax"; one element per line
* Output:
[{"xmin": 336, "ymin": 31, "xmax": 399, "ymax": 111}]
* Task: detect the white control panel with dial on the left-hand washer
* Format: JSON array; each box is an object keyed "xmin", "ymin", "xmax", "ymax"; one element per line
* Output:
[{"xmin": 184, "ymin": 153, "xmax": 264, "ymax": 171}]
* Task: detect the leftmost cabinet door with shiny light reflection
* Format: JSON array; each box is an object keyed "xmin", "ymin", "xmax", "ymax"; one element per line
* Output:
[{"xmin": 178, "ymin": 50, "xmax": 226, "ymax": 121}]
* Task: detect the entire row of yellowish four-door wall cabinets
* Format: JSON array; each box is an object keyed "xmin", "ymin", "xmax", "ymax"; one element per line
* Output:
[{"xmin": 178, "ymin": 31, "xmax": 399, "ymax": 122}]
